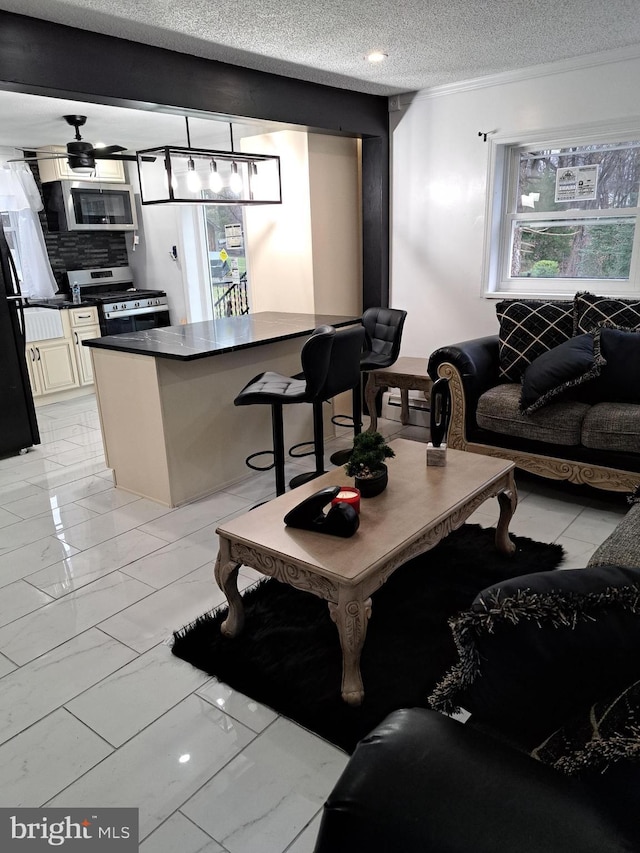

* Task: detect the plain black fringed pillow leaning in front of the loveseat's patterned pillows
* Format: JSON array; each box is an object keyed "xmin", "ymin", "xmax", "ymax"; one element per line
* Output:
[{"xmin": 520, "ymin": 332, "xmax": 605, "ymax": 415}]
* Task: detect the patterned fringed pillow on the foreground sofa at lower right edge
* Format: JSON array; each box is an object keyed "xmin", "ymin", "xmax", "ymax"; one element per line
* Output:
[{"xmin": 531, "ymin": 681, "xmax": 640, "ymax": 776}]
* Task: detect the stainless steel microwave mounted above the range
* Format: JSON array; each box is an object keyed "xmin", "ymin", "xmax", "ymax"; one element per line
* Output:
[{"xmin": 42, "ymin": 181, "xmax": 138, "ymax": 231}]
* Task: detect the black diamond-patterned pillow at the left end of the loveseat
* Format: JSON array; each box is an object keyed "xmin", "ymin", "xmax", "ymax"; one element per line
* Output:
[{"xmin": 496, "ymin": 299, "xmax": 574, "ymax": 382}]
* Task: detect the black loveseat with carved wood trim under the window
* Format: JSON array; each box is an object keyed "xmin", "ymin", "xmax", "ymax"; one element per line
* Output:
[{"xmin": 428, "ymin": 293, "xmax": 640, "ymax": 491}]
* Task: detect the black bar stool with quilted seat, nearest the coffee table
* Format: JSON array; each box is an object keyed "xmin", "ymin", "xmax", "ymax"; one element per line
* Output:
[{"xmin": 234, "ymin": 326, "xmax": 365, "ymax": 495}]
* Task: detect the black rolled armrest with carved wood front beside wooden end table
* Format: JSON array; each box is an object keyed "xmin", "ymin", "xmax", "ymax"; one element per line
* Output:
[{"xmin": 427, "ymin": 335, "xmax": 500, "ymax": 439}]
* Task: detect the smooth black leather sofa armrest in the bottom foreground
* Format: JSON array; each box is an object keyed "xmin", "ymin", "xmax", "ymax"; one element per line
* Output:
[{"xmin": 315, "ymin": 708, "xmax": 640, "ymax": 853}]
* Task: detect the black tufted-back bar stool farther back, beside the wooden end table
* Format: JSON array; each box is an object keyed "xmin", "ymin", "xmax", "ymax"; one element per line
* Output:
[{"xmin": 331, "ymin": 308, "xmax": 407, "ymax": 465}]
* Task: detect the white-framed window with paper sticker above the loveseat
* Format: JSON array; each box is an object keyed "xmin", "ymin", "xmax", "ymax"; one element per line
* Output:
[{"xmin": 487, "ymin": 131, "xmax": 640, "ymax": 297}]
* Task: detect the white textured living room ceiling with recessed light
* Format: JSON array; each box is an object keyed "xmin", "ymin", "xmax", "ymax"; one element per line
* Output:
[{"xmin": 0, "ymin": 0, "xmax": 640, "ymax": 95}]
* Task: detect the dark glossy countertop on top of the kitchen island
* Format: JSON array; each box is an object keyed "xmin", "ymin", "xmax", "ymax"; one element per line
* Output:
[{"xmin": 83, "ymin": 311, "xmax": 360, "ymax": 361}]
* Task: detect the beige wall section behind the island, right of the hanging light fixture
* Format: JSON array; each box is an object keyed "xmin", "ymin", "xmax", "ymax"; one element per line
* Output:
[{"xmin": 242, "ymin": 131, "xmax": 362, "ymax": 314}]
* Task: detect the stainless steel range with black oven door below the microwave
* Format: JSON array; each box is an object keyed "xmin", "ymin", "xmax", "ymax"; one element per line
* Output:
[{"xmin": 67, "ymin": 267, "xmax": 171, "ymax": 335}]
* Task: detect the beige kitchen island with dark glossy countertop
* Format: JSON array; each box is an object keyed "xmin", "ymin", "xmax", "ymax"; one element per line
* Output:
[{"xmin": 85, "ymin": 311, "xmax": 360, "ymax": 507}]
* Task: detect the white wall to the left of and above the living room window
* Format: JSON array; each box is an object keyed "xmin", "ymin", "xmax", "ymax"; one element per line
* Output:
[{"xmin": 391, "ymin": 53, "xmax": 640, "ymax": 358}]
